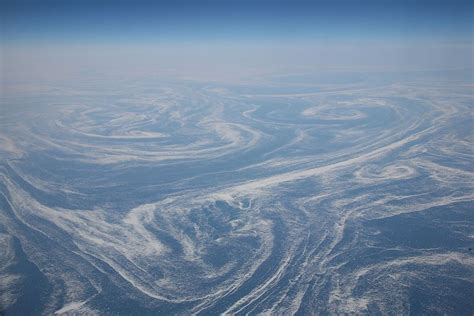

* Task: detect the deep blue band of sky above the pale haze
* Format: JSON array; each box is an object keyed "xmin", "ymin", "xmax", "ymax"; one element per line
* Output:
[{"xmin": 1, "ymin": 0, "xmax": 473, "ymax": 43}]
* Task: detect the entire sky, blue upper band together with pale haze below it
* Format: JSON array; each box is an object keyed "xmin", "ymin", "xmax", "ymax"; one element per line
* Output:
[{"xmin": 0, "ymin": 0, "xmax": 474, "ymax": 83}]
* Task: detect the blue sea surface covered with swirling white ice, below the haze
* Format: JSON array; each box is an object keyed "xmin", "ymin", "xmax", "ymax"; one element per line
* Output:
[{"xmin": 0, "ymin": 75, "xmax": 474, "ymax": 315}]
